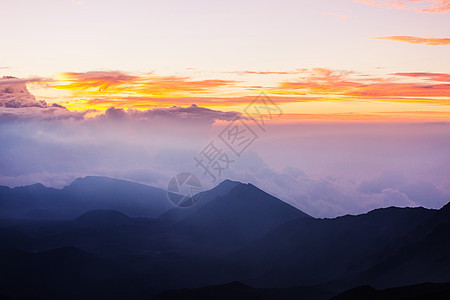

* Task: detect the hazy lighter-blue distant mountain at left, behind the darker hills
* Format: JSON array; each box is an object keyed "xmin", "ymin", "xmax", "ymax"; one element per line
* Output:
[{"xmin": 0, "ymin": 176, "xmax": 172, "ymax": 219}]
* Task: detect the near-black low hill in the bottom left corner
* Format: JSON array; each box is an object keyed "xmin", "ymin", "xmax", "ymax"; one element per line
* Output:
[{"xmin": 0, "ymin": 247, "xmax": 123, "ymax": 299}]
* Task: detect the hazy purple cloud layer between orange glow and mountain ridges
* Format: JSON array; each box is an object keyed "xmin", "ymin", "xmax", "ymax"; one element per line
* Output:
[{"xmin": 0, "ymin": 102, "xmax": 450, "ymax": 217}]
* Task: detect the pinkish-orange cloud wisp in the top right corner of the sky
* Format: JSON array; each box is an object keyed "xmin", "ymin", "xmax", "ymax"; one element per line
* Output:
[{"xmin": 354, "ymin": 0, "xmax": 450, "ymax": 13}]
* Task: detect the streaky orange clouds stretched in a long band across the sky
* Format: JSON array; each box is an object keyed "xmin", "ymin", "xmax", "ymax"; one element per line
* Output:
[{"xmin": 37, "ymin": 68, "xmax": 450, "ymax": 110}]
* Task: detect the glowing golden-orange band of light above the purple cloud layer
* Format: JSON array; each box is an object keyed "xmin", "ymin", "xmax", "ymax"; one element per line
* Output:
[{"xmin": 20, "ymin": 68, "xmax": 450, "ymax": 120}]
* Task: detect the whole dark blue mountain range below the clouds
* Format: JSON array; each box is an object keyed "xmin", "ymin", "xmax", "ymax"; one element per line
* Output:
[{"xmin": 0, "ymin": 177, "xmax": 450, "ymax": 299}]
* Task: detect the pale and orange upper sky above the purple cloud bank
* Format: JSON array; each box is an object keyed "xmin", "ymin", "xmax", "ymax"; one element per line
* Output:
[{"xmin": 0, "ymin": 0, "xmax": 450, "ymax": 121}]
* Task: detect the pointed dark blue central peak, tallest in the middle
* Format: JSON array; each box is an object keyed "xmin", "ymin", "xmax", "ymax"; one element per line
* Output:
[{"xmin": 172, "ymin": 183, "xmax": 311, "ymax": 249}]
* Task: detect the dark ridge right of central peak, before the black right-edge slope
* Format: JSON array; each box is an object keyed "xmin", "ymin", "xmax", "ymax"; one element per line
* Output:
[{"xmin": 232, "ymin": 207, "xmax": 436, "ymax": 286}]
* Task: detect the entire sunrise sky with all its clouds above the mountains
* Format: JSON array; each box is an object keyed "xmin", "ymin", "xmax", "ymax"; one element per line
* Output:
[{"xmin": 0, "ymin": 0, "xmax": 450, "ymax": 217}]
